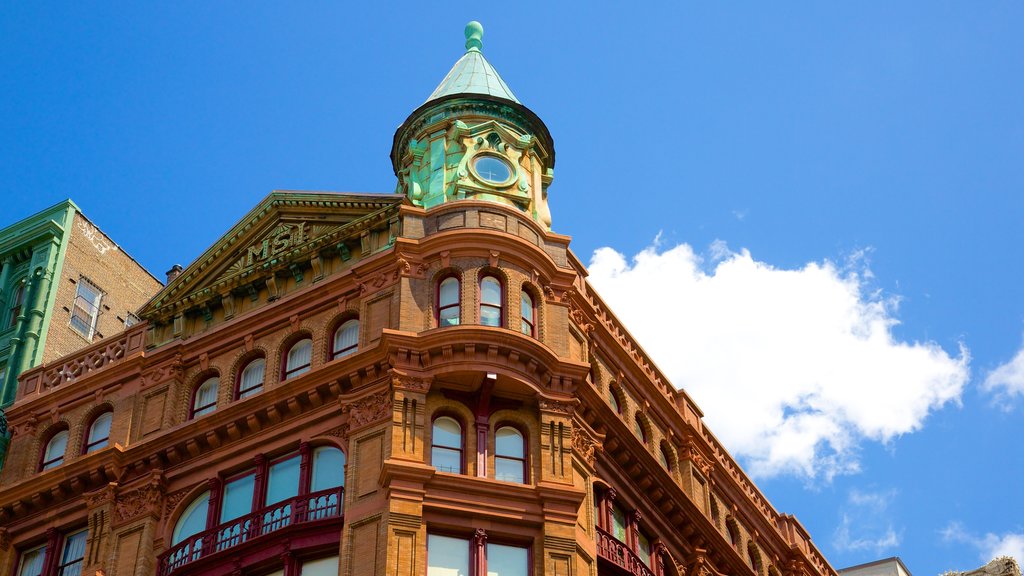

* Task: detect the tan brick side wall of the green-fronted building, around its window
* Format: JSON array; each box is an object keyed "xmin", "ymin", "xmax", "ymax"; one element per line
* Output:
[{"xmin": 43, "ymin": 213, "xmax": 162, "ymax": 362}]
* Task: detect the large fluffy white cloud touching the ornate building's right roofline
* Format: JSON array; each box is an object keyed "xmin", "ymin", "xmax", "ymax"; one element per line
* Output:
[{"xmin": 590, "ymin": 242, "xmax": 969, "ymax": 481}]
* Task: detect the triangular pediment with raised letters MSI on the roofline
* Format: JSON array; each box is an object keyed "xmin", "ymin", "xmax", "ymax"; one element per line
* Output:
[{"xmin": 139, "ymin": 191, "xmax": 404, "ymax": 319}]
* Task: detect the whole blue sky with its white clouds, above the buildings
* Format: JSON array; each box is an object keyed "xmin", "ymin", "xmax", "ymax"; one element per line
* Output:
[{"xmin": 0, "ymin": 1, "xmax": 1024, "ymax": 576}]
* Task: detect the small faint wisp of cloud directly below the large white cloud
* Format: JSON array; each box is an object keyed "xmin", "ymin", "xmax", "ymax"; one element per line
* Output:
[{"xmin": 833, "ymin": 490, "xmax": 900, "ymax": 556}]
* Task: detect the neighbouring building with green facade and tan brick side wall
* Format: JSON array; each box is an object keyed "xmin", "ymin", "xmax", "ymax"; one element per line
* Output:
[{"xmin": 0, "ymin": 200, "xmax": 163, "ymax": 466}]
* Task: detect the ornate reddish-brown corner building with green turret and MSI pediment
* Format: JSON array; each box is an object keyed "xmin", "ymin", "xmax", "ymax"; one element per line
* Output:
[{"xmin": 0, "ymin": 23, "xmax": 836, "ymax": 576}]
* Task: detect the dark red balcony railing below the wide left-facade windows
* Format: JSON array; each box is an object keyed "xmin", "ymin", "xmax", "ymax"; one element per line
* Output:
[{"xmin": 158, "ymin": 487, "xmax": 345, "ymax": 576}]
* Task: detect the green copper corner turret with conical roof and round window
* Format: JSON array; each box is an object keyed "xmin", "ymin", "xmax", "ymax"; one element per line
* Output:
[{"xmin": 391, "ymin": 22, "xmax": 555, "ymax": 230}]
